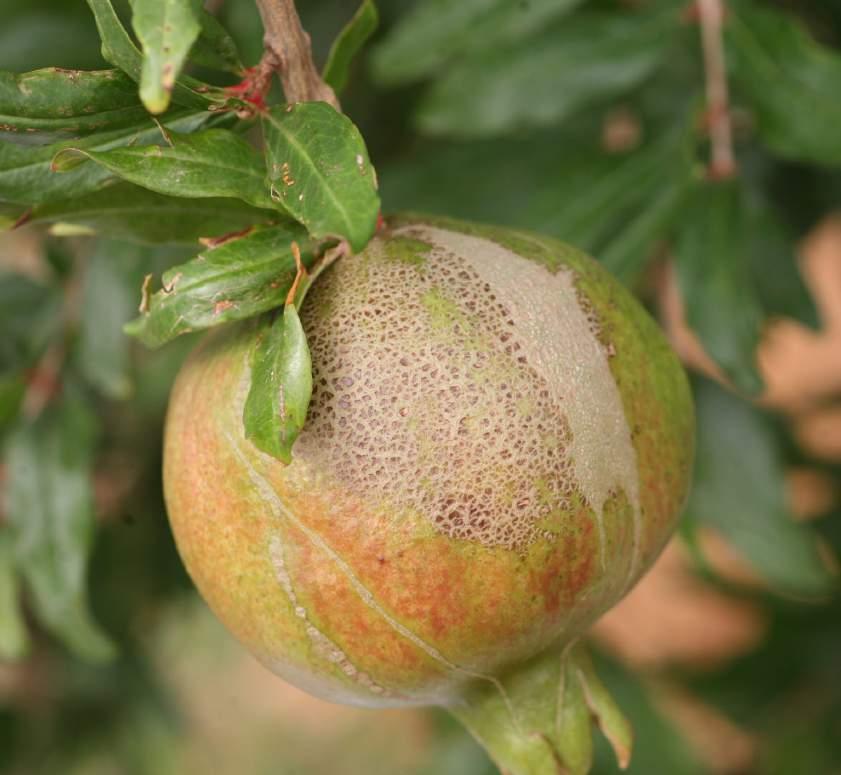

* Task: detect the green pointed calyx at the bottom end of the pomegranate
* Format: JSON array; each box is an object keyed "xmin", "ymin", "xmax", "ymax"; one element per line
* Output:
[{"xmin": 449, "ymin": 642, "xmax": 632, "ymax": 775}]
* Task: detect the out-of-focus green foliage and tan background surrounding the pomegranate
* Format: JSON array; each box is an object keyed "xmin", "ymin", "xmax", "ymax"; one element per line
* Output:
[{"xmin": 0, "ymin": 0, "xmax": 841, "ymax": 775}]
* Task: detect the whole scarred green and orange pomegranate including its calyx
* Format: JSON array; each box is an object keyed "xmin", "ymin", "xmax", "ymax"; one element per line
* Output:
[{"xmin": 164, "ymin": 218, "xmax": 694, "ymax": 775}]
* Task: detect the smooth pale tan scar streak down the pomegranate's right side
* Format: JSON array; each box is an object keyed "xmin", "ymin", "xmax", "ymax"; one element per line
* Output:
[{"xmin": 415, "ymin": 226, "xmax": 642, "ymax": 579}]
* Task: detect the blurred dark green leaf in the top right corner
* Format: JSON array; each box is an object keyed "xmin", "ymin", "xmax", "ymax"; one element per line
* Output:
[{"xmin": 726, "ymin": 0, "xmax": 841, "ymax": 165}]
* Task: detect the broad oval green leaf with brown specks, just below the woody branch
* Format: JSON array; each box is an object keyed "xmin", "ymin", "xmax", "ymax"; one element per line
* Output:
[{"xmin": 263, "ymin": 102, "xmax": 380, "ymax": 251}]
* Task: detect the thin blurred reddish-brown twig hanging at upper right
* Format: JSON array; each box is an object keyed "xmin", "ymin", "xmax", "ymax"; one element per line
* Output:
[{"xmin": 697, "ymin": 0, "xmax": 736, "ymax": 180}]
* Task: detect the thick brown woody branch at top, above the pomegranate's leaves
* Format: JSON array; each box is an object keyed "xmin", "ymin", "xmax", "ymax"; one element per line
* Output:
[{"xmin": 256, "ymin": 0, "xmax": 341, "ymax": 110}]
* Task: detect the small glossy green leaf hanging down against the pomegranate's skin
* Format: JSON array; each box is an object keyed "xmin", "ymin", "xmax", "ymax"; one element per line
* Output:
[{"xmin": 243, "ymin": 303, "xmax": 312, "ymax": 463}]
